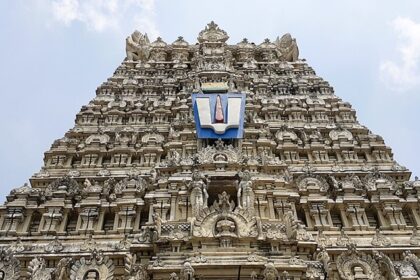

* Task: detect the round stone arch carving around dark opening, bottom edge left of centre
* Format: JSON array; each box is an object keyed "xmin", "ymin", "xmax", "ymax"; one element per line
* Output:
[{"xmin": 70, "ymin": 249, "xmax": 114, "ymax": 280}]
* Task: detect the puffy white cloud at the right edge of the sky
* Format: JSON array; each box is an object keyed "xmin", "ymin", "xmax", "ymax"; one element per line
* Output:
[{"xmin": 380, "ymin": 17, "xmax": 420, "ymax": 92}]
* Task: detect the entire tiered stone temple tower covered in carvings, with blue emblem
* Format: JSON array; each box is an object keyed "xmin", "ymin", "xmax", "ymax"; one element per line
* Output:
[{"xmin": 0, "ymin": 22, "xmax": 420, "ymax": 280}]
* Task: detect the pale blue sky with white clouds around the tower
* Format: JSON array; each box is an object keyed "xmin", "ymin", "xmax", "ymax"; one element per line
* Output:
[{"xmin": 0, "ymin": 0, "xmax": 420, "ymax": 201}]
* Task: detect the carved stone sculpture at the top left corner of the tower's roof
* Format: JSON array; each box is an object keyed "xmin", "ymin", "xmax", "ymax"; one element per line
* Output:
[{"xmin": 125, "ymin": 30, "xmax": 150, "ymax": 61}]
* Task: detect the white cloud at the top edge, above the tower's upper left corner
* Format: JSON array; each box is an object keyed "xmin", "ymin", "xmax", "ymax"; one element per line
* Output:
[{"xmin": 51, "ymin": 0, "xmax": 159, "ymax": 38}]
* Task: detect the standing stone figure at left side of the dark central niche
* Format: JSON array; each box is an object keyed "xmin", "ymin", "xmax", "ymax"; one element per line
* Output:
[{"xmin": 188, "ymin": 170, "xmax": 209, "ymax": 217}]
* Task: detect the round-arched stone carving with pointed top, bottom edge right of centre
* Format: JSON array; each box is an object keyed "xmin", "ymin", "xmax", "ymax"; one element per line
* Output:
[{"xmin": 336, "ymin": 244, "xmax": 381, "ymax": 280}]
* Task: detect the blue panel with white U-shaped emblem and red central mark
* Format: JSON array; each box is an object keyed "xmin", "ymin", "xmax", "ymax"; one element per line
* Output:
[{"xmin": 192, "ymin": 93, "xmax": 245, "ymax": 139}]
